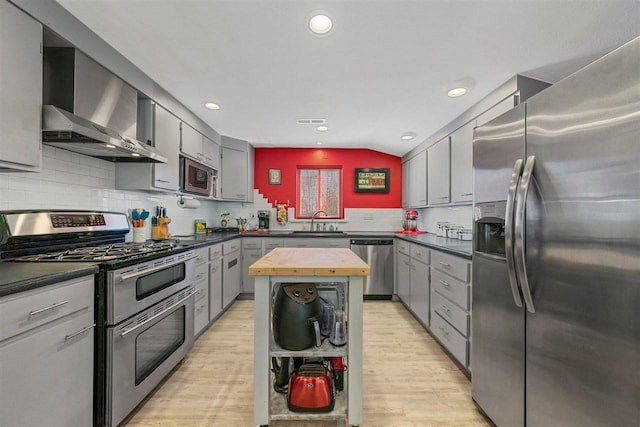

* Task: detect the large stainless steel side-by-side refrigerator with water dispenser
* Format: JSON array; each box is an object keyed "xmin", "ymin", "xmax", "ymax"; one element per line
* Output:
[{"xmin": 471, "ymin": 38, "xmax": 640, "ymax": 427}]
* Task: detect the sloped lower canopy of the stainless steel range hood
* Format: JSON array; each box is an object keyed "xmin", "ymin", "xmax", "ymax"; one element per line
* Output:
[{"xmin": 42, "ymin": 105, "xmax": 167, "ymax": 163}]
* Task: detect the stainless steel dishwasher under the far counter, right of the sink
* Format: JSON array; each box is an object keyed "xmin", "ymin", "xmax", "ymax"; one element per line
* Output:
[{"xmin": 351, "ymin": 239, "xmax": 393, "ymax": 299}]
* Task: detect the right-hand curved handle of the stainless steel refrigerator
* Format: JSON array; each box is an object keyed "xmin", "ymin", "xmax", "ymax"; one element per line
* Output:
[{"xmin": 514, "ymin": 156, "xmax": 536, "ymax": 313}]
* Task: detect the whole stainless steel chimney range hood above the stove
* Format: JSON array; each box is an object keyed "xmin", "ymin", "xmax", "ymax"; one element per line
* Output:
[{"xmin": 42, "ymin": 47, "xmax": 167, "ymax": 163}]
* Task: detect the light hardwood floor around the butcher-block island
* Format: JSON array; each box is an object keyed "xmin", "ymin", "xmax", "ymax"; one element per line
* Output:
[{"xmin": 126, "ymin": 300, "xmax": 492, "ymax": 427}]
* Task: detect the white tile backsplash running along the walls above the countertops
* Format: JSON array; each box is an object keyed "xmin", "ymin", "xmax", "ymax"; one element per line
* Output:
[{"xmin": 0, "ymin": 145, "xmax": 404, "ymax": 238}]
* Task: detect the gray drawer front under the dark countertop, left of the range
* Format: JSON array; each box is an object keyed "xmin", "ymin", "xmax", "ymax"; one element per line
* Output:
[{"xmin": 0, "ymin": 276, "xmax": 94, "ymax": 341}]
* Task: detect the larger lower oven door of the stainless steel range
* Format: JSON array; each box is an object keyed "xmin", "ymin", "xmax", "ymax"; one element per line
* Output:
[{"xmin": 106, "ymin": 286, "xmax": 195, "ymax": 426}]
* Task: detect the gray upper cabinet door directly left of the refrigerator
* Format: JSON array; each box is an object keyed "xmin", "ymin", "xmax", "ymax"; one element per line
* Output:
[{"xmin": 451, "ymin": 121, "xmax": 475, "ymax": 203}]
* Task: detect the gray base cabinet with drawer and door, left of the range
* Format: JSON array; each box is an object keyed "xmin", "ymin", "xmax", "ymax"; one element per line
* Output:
[{"xmin": 0, "ymin": 276, "xmax": 95, "ymax": 427}]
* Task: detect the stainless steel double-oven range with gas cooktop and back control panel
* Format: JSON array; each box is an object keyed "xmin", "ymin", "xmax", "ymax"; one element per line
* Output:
[{"xmin": 0, "ymin": 211, "xmax": 195, "ymax": 427}]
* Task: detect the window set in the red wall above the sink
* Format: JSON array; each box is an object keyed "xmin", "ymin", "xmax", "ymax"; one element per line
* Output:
[{"xmin": 296, "ymin": 167, "xmax": 342, "ymax": 218}]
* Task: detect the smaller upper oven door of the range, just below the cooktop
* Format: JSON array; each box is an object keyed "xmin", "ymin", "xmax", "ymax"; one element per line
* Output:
[{"xmin": 106, "ymin": 251, "xmax": 196, "ymax": 325}]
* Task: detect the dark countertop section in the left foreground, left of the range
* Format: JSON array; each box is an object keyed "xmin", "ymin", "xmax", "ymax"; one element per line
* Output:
[{"xmin": 0, "ymin": 261, "xmax": 98, "ymax": 297}]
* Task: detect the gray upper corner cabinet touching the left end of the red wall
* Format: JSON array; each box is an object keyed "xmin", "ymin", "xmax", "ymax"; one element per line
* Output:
[{"xmin": 220, "ymin": 147, "xmax": 249, "ymax": 201}]
